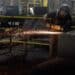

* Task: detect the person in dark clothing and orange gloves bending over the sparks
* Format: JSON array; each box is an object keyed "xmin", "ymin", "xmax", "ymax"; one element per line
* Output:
[{"xmin": 45, "ymin": 4, "xmax": 72, "ymax": 31}]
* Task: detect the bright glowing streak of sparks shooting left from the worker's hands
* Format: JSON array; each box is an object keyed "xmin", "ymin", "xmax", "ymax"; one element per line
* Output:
[{"xmin": 14, "ymin": 30, "xmax": 63, "ymax": 37}]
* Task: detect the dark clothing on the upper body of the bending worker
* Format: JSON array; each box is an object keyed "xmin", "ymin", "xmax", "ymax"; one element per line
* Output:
[{"xmin": 46, "ymin": 12, "xmax": 72, "ymax": 31}]
